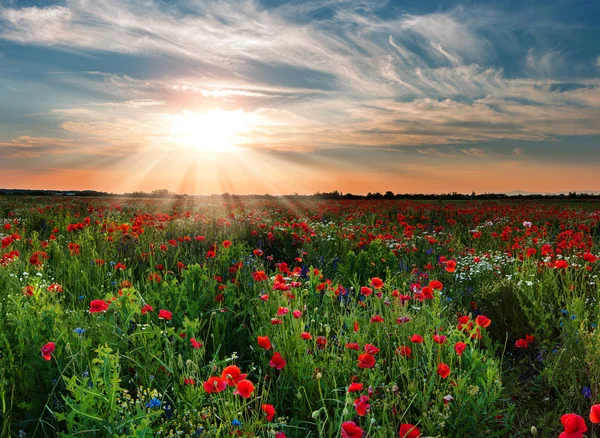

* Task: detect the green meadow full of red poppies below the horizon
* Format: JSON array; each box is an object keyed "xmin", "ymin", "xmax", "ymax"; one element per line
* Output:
[{"xmin": 0, "ymin": 197, "xmax": 600, "ymax": 438}]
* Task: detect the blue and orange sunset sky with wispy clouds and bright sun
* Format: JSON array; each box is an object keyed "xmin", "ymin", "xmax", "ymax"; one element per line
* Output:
[{"xmin": 0, "ymin": 0, "xmax": 600, "ymax": 194}]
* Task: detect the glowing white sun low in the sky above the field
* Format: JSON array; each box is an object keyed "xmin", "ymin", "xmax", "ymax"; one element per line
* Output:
[{"xmin": 169, "ymin": 109, "xmax": 252, "ymax": 153}]
